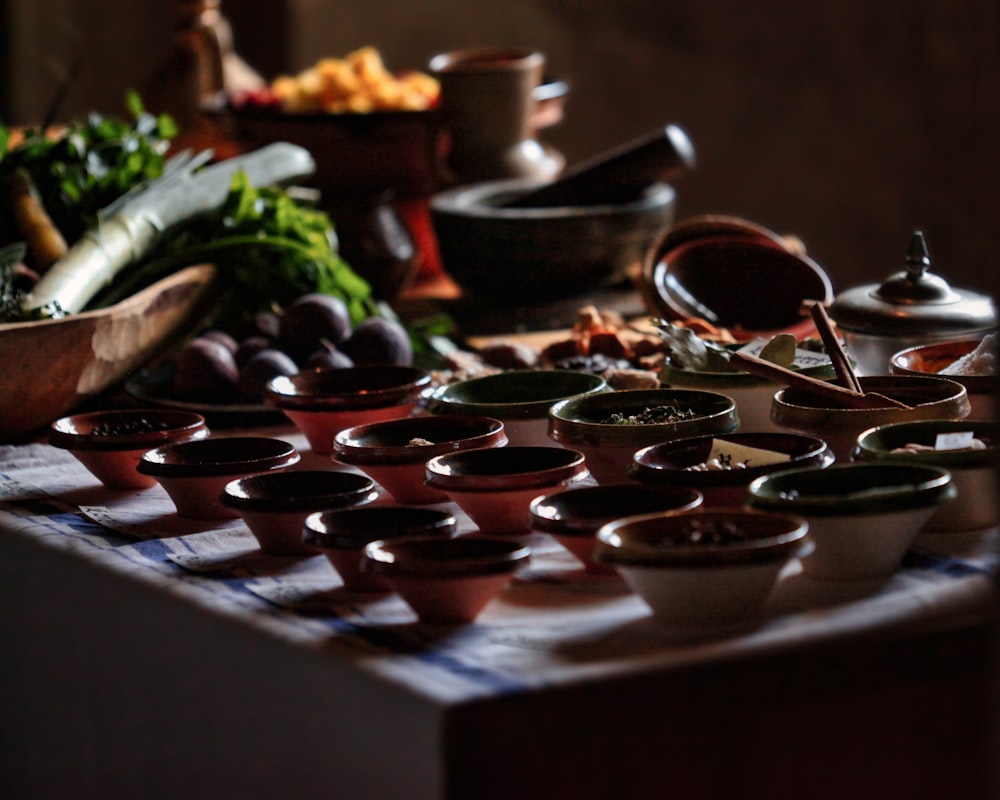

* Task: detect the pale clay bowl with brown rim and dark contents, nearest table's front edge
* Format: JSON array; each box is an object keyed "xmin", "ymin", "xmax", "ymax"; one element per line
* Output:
[{"xmin": 594, "ymin": 508, "xmax": 808, "ymax": 639}]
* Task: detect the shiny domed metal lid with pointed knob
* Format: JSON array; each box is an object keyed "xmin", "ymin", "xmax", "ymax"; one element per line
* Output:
[{"xmin": 830, "ymin": 230, "xmax": 997, "ymax": 337}]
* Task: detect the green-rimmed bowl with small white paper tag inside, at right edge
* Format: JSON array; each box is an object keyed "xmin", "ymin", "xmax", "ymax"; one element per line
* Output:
[{"xmin": 852, "ymin": 419, "xmax": 1000, "ymax": 533}]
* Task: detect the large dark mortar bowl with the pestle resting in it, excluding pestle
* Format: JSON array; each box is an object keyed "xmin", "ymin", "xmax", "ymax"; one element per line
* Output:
[{"xmin": 431, "ymin": 178, "xmax": 676, "ymax": 305}]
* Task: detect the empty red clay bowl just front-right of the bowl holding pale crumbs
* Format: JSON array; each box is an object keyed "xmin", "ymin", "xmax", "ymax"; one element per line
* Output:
[{"xmin": 426, "ymin": 445, "xmax": 589, "ymax": 536}]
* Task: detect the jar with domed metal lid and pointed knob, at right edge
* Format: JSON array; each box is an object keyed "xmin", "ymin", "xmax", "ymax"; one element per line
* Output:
[{"xmin": 830, "ymin": 230, "xmax": 997, "ymax": 375}]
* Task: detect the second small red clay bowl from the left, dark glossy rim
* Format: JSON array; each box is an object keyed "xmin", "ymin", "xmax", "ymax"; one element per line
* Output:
[{"xmin": 138, "ymin": 436, "xmax": 301, "ymax": 519}]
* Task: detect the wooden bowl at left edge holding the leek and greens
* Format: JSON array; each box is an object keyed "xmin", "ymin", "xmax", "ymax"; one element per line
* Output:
[{"xmin": 0, "ymin": 264, "xmax": 215, "ymax": 442}]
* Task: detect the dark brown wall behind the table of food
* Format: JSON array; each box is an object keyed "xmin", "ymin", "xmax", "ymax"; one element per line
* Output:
[{"xmin": 0, "ymin": 0, "xmax": 1000, "ymax": 291}]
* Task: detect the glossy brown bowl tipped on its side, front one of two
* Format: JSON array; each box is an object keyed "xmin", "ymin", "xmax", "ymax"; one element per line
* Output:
[{"xmin": 646, "ymin": 233, "xmax": 833, "ymax": 341}]
